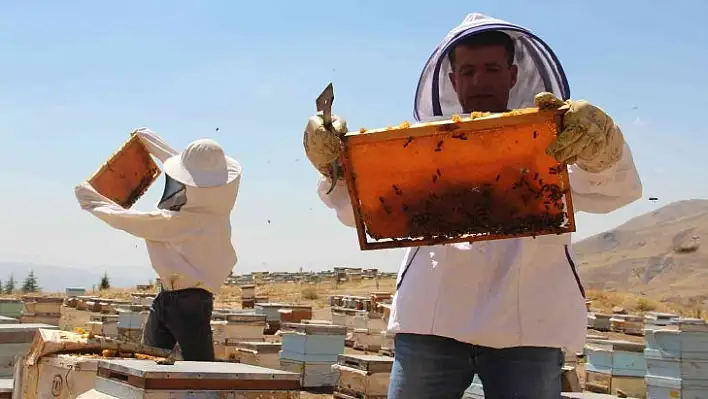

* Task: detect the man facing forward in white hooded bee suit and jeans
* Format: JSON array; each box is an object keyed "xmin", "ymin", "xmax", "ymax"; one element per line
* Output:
[{"xmin": 305, "ymin": 14, "xmax": 642, "ymax": 399}]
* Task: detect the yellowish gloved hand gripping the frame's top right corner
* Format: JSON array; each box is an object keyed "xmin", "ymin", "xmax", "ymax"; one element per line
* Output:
[{"xmin": 534, "ymin": 92, "xmax": 624, "ymax": 173}]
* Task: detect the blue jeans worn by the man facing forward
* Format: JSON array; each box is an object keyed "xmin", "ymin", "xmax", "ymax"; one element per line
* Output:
[{"xmin": 388, "ymin": 334, "xmax": 564, "ymax": 399}]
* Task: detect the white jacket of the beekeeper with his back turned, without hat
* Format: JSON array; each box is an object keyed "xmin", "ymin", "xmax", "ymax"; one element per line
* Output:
[{"xmin": 75, "ymin": 129, "xmax": 241, "ymax": 293}]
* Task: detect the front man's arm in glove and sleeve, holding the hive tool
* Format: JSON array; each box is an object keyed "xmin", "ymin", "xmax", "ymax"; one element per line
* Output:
[{"xmin": 303, "ymin": 115, "xmax": 355, "ymax": 227}]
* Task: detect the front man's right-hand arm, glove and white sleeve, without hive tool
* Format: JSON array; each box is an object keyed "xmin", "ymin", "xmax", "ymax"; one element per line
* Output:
[{"xmin": 536, "ymin": 93, "xmax": 642, "ymax": 213}]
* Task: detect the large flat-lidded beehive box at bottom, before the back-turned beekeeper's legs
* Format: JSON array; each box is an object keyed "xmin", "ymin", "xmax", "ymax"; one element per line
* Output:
[{"xmin": 77, "ymin": 360, "xmax": 300, "ymax": 399}]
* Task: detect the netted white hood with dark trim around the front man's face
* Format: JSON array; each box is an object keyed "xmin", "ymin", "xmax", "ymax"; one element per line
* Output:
[{"xmin": 414, "ymin": 13, "xmax": 570, "ymax": 121}]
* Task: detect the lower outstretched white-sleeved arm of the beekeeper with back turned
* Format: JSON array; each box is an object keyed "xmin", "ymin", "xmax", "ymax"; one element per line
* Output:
[{"xmin": 74, "ymin": 183, "xmax": 192, "ymax": 242}]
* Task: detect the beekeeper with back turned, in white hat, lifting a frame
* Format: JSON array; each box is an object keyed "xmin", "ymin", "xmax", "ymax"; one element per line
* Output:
[{"xmin": 75, "ymin": 129, "xmax": 241, "ymax": 361}]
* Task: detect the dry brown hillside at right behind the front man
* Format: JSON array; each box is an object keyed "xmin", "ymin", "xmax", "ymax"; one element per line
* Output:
[{"xmin": 573, "ymin": 199, "xmax": 708, "ymax": 304}]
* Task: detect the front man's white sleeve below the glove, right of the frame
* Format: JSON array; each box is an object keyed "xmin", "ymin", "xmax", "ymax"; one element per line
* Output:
[{"xmin": 569, "ymin": 143, "xmax": 642, "ymax": 213}]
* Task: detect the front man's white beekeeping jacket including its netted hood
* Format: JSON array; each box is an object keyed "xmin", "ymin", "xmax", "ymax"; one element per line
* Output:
[{"xmin": 319, "ymin": 14, "xmax": 641, "ymax": 352}]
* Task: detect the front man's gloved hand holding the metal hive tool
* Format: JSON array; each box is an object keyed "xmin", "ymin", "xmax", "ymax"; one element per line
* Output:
[{"xmin": 303, "ymin": 114, "xmax": 347, "ymax": 182}]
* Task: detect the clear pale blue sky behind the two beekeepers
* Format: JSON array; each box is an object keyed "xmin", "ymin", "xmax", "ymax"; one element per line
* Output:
[{"xmin": 0, "ymin": 0, "xmax": 708, "ymax": 272}]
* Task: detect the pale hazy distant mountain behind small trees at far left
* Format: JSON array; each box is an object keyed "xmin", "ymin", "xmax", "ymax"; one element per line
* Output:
[{"xmin": 0, "ymin": 262, "xmax": 155, "ymax": 292}]
